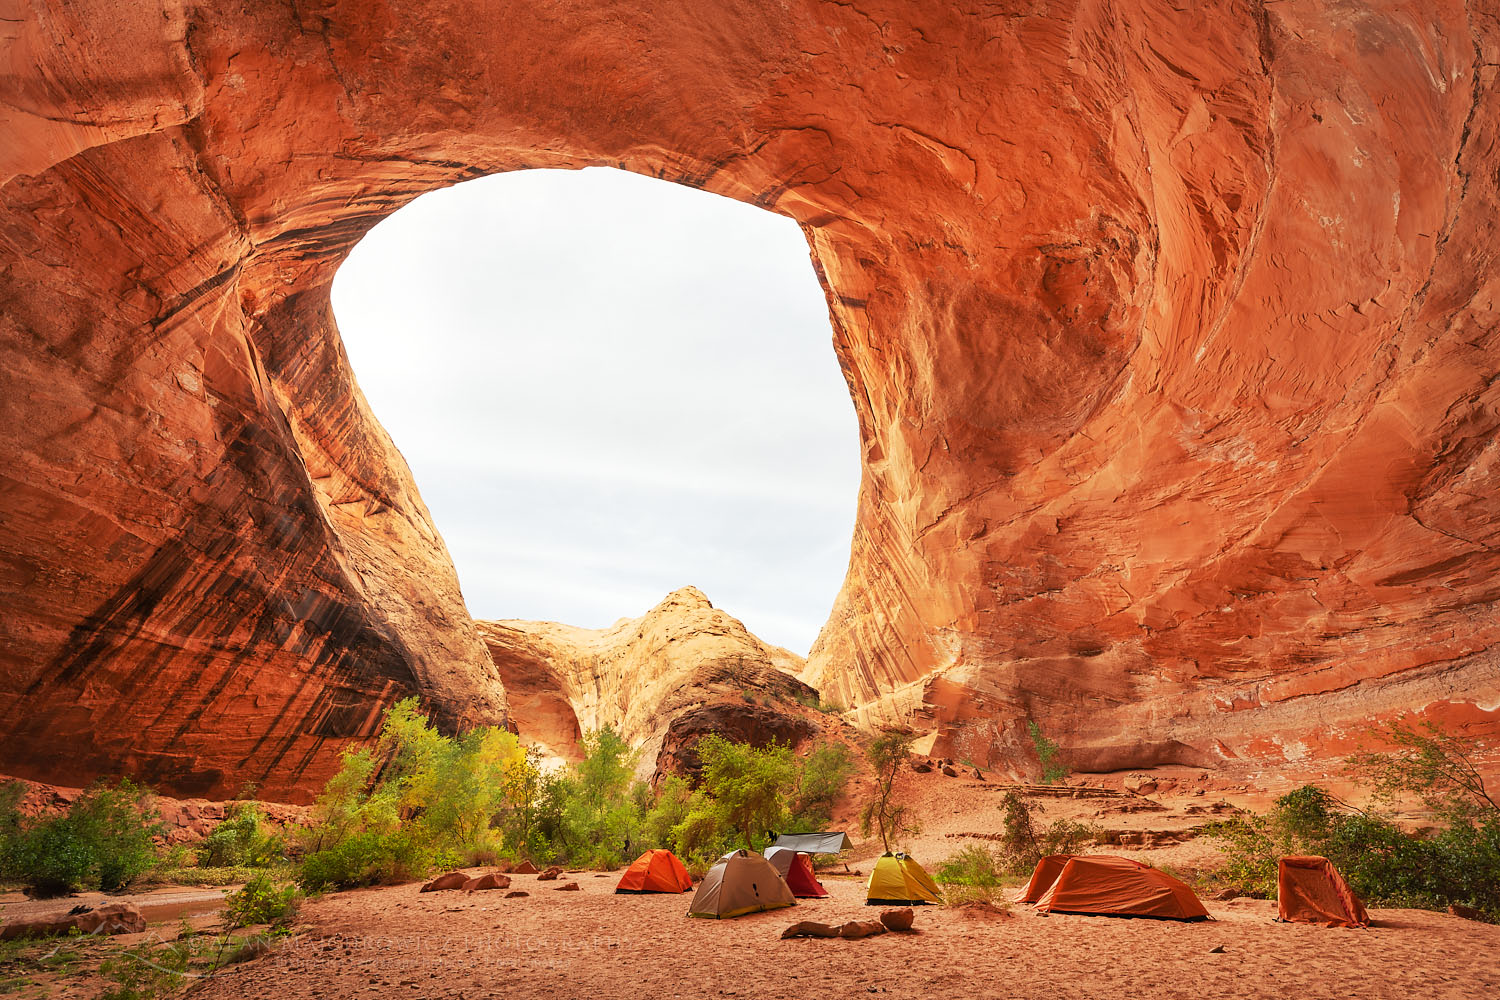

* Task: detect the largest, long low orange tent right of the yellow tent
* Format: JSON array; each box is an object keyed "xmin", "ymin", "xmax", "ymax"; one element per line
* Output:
[{"xmin": 1037, "ymin": 855, "xmax": 1209, "ymax": 921}]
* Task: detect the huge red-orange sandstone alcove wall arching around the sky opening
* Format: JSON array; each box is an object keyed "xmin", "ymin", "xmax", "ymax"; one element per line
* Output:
[{"xmin": 0, "ymin": 0, "xmax": 1500, "ymax": 795}]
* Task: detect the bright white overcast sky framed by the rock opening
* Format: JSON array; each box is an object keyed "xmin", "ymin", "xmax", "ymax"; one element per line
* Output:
[{"xmin": 333, "ymin": 168, "xmax": 860, "ymax": 655}]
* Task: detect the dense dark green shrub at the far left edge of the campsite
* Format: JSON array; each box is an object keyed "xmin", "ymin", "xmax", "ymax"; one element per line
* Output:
[{"xmin": 0, "ymin": 778, "xmax": 165, "ymax": 895}]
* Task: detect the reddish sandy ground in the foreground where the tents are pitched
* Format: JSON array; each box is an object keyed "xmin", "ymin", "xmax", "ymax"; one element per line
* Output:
[{"xmin": 194, "ymin": 873, "xmax": 1500, "ymax": 1000}]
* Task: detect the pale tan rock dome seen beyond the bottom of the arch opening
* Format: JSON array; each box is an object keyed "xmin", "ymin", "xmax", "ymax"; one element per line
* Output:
[{"xmin": 476, "ymin": 586, "xmax": 821, "ymax": 780}]
